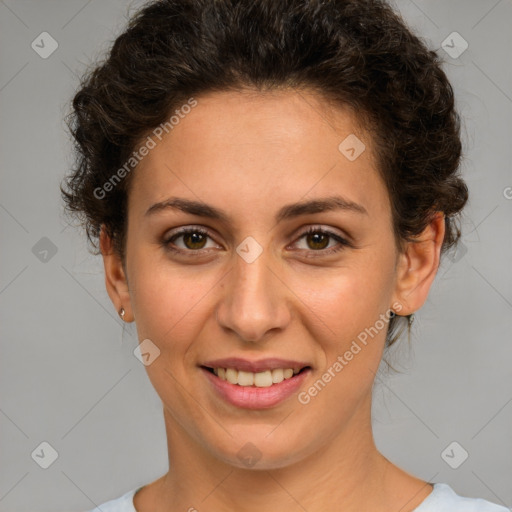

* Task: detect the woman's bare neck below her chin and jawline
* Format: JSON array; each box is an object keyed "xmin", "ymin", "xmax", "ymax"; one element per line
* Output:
[{"xmin": 153, "ymin": 397, "xmax": 396, "ymax": 512}]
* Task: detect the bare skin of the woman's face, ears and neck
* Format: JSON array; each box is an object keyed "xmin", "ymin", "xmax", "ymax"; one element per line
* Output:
[{"xmin": 100, "ymin": 90, "xmax": 444, "ymax": 512}]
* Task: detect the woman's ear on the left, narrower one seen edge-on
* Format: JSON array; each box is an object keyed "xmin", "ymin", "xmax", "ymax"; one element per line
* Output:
[{"xmin": 100, "ymin": 225, "xmax": 134, "ymax": 322}]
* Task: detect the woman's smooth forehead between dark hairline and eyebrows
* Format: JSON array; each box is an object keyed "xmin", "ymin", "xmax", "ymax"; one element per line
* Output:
[{"xmin": 130, "ymin": 90, "xmax": 385, "ymax": 222}]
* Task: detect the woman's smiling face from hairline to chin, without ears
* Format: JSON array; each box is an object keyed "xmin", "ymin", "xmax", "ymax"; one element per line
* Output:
[{"xmin": 118, "ymin": 92, "xmax": 404, "ymax": 468}]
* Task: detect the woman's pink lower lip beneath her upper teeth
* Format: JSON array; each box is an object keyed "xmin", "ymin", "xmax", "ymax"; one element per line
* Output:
[{"xmin": 201, "ymin": 368, "xmax": 311, "ymax": 409}]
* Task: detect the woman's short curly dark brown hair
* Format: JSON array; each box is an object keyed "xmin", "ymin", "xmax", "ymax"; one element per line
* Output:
[{"xmin": 61, "ymin": 0, "xmax": 468, "ymax": 346}]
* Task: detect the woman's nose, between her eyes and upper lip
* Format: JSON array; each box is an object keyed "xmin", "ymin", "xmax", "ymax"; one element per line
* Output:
[{"xmin": 217, "ymin": 245, "xmax": 291, "ymax": 342}]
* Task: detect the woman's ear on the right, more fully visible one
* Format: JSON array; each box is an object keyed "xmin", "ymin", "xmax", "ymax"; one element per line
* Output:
[{"xmin": 392, "ymin": 212, "xmax": 445, "ymax": 316}]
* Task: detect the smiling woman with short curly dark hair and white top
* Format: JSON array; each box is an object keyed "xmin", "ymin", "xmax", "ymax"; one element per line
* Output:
[{"xmin": 62, "ymin": 0, "xmax": 506, "ymax": 512}]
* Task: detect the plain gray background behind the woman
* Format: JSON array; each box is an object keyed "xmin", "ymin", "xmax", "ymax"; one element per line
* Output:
[{"xmin": 0, "ymin": 0, "xmax": 512, "ymax": 512}]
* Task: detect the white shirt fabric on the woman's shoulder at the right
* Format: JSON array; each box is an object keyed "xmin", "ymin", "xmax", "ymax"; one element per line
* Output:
[{"xmin": 413, "ymin": 483, "xmax": 511, "ymax": 512}]
